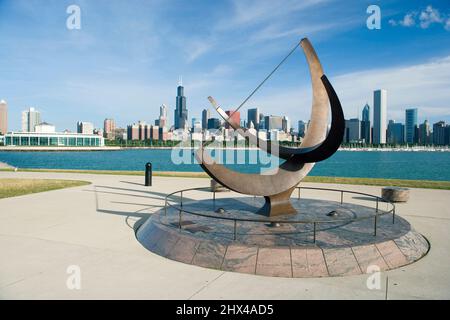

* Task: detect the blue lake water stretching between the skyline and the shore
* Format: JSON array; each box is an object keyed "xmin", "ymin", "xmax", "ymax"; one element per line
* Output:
[{"xmin": 0, "ymin": 149, "xmax": 450, "ymax": 181}]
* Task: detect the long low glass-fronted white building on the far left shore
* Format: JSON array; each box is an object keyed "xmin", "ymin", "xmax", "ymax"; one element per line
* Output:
[{"xmin": 4, "ymin": 132, "xmax": 105, "ymax": 147}]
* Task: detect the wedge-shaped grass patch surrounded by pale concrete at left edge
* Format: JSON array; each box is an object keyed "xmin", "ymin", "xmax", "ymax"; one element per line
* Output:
[{"xmin": 0, "ymin": 179, "xmax": 90, "ymax": 199}]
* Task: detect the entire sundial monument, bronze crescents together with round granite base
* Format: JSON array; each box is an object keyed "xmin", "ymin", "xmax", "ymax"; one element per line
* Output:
[{"xmin": 136, "ymin": 39, "xmax": 430, "ymax": 278}]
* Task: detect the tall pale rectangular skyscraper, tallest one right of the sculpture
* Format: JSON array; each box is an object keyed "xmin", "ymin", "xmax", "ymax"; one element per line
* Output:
[{"xmin": 372, "ymin": 89, "xmax": 387, "ymax": 144}]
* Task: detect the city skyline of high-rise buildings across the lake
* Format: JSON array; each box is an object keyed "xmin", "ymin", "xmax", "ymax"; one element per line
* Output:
[{"xmin": 0, "ymin": 84, "xmax": 450, "ymax": 145}]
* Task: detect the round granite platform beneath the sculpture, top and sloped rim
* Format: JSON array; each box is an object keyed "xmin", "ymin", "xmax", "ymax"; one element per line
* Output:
[{"xmin": 136, "ymin": 197, "xmax": 430, "ymax": 278}]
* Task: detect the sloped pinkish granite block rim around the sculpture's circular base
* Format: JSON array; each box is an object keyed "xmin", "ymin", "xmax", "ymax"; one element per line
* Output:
[{"xmin": 136, "ymin": 217, "xmax": 429, "ymax": 278}]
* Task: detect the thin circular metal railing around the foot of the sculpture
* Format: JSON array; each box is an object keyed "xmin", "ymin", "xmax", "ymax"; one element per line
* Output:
[{"xmin": 164, "ymin": 187, "xmax": 395, "ymax": 243}]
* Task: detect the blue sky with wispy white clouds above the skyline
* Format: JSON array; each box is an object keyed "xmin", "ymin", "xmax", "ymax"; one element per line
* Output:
[{"xmin": 0, "ymin": 0, "xmax": 450, "ymax": 130}]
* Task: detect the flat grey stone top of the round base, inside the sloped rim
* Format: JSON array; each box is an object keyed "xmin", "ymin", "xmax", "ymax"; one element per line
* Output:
[{"xmin": 155, "ymin": 195, "xmax": 411, "ymax": 249}]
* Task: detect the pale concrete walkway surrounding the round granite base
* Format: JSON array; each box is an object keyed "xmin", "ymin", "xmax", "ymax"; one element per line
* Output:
[{"xmin": 0, "ymin": 172, "xmax": 450, "ymax": 299}]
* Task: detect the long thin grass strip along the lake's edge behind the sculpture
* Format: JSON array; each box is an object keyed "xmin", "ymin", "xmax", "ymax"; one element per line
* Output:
[{"xmin": 0, "ymin": 169, "xmax": 450, "ymax": 190}]
